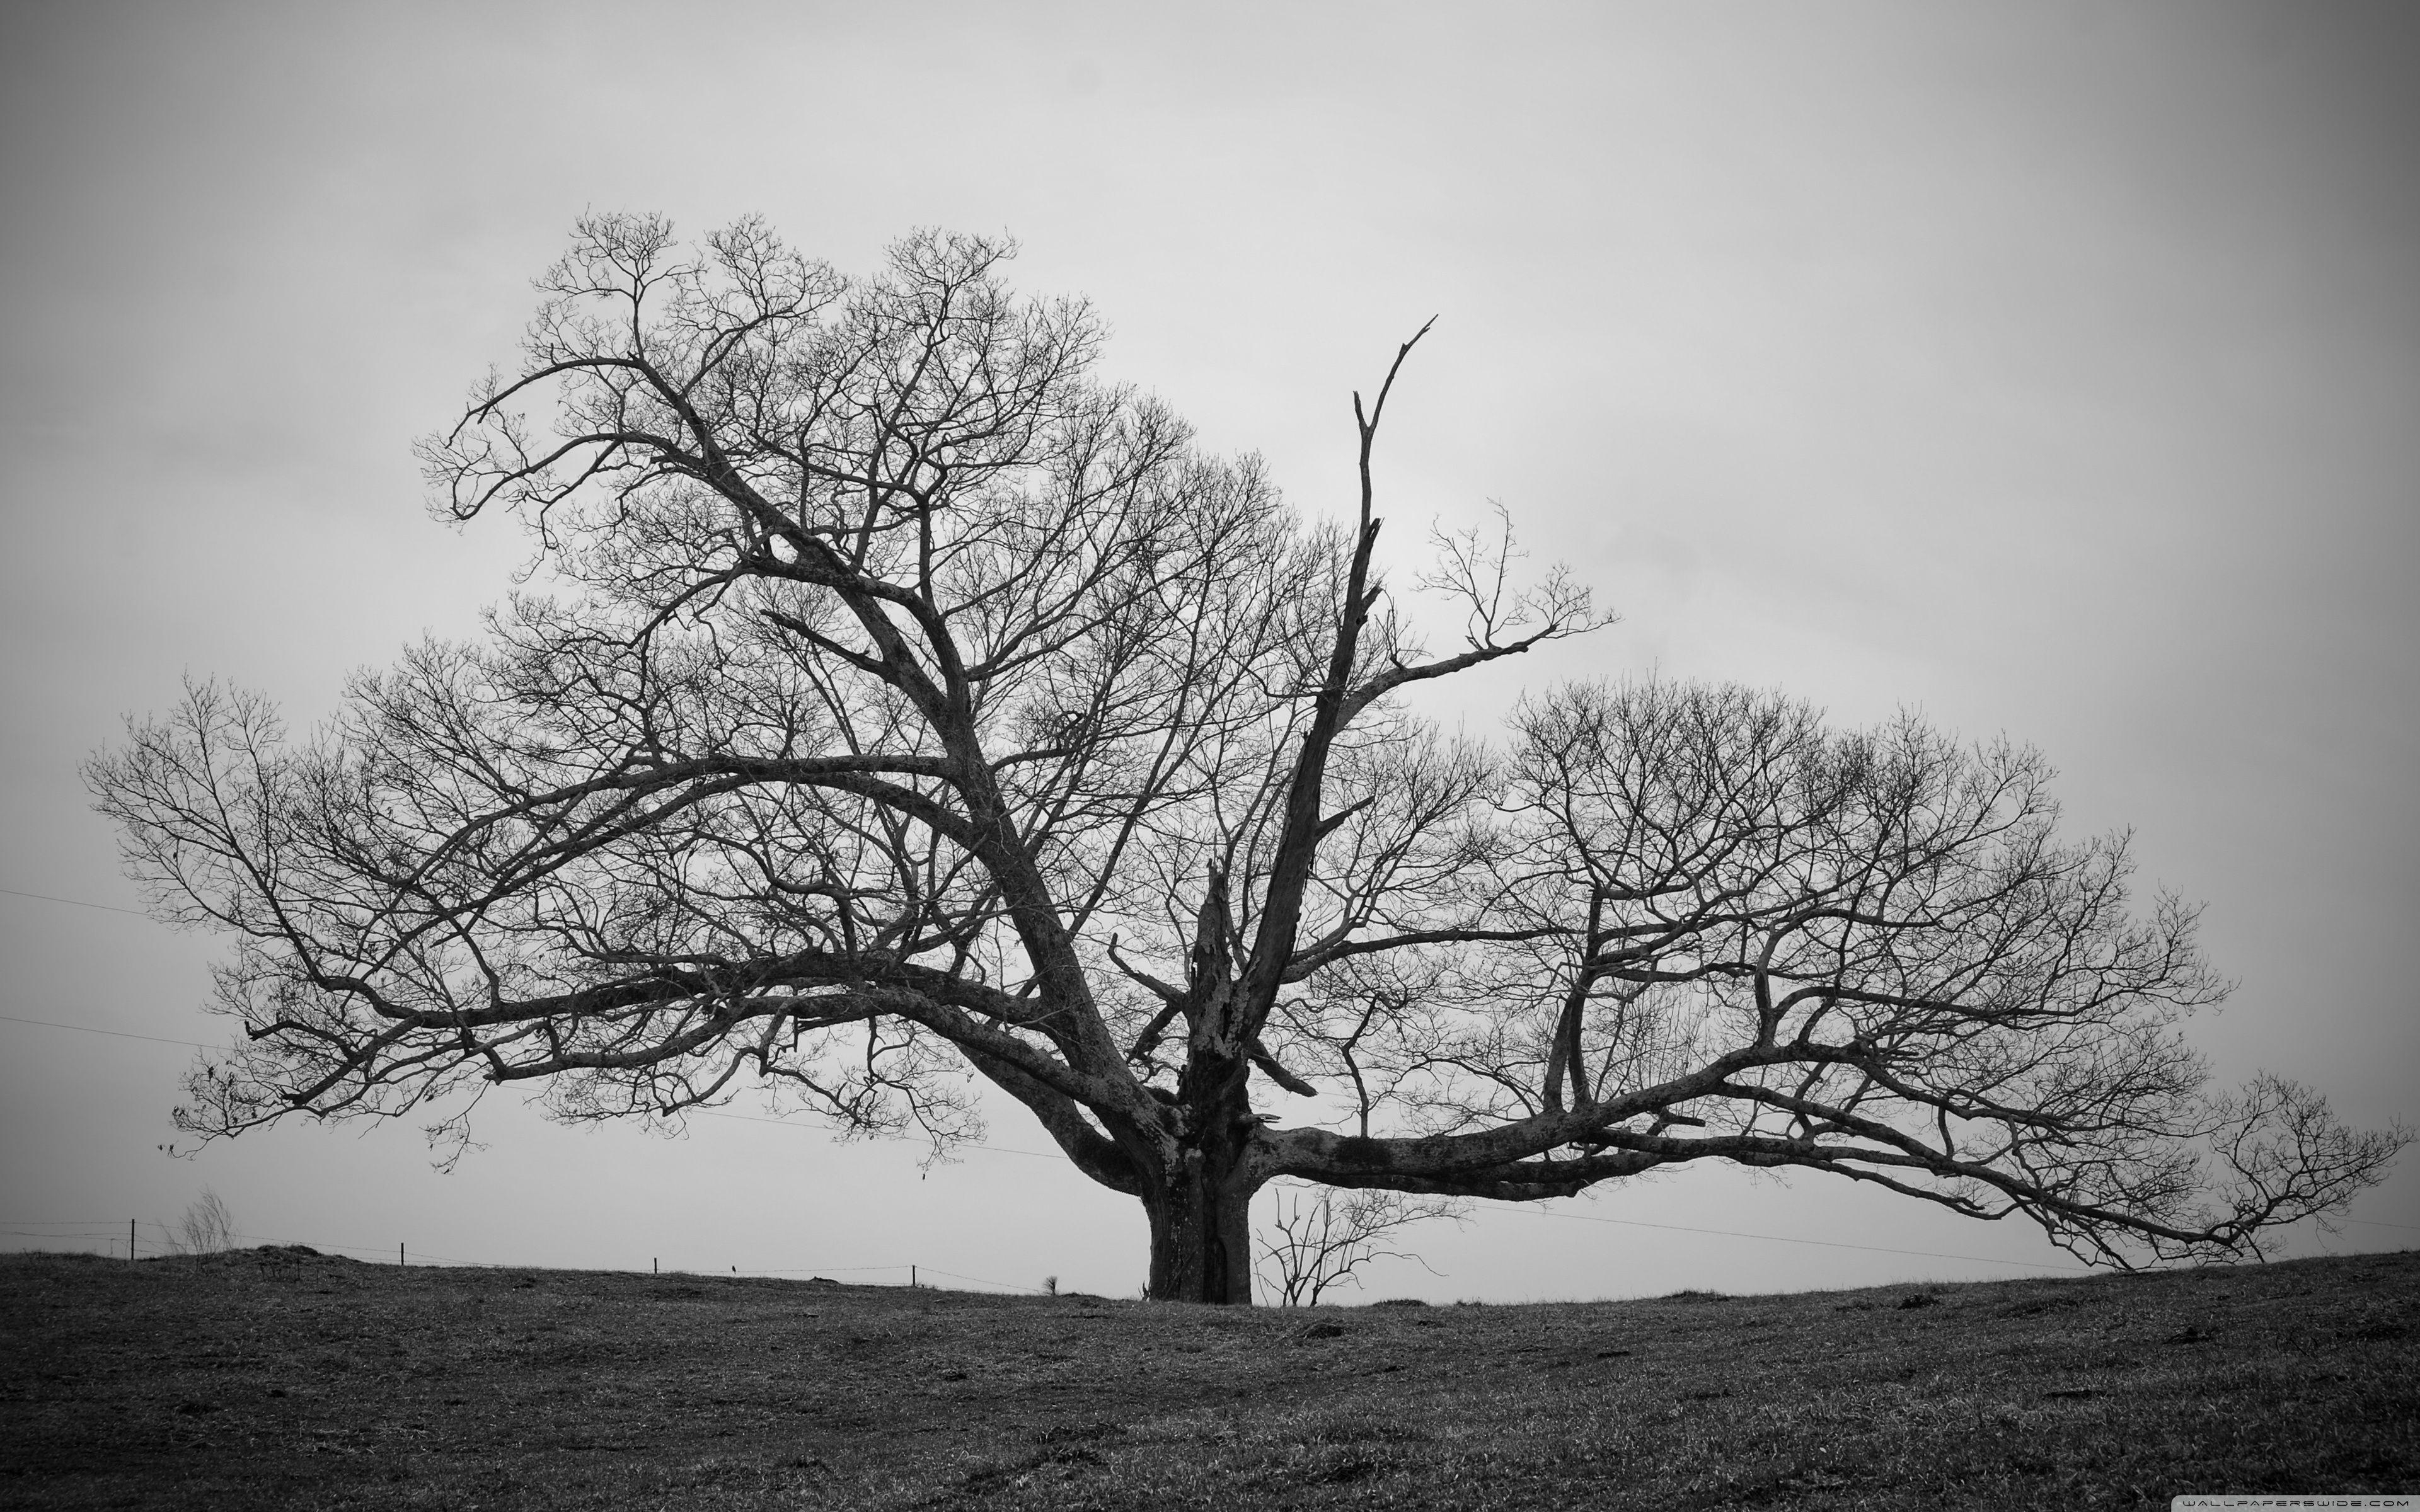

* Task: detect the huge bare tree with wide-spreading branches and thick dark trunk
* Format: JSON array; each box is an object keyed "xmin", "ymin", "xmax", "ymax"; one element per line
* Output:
[{"xmin": 87, "ymin": 215, "xmax": 2406, "ymax": 1302}]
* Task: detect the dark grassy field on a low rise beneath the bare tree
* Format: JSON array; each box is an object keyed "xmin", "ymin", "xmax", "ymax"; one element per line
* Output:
[{"xmin": 0, "ymin": 1251, "xmax": 2420, "ymax": 1512}]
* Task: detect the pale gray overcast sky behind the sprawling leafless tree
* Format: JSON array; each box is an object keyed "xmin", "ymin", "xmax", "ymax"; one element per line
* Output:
[{"xmin": 0, "ymin": 3, "xmax": 2420, "ymax": 1299}]
